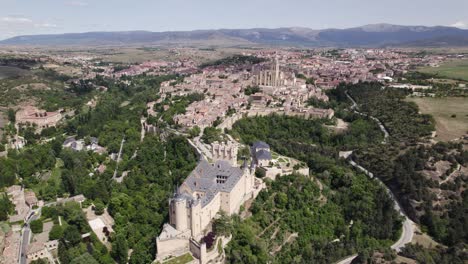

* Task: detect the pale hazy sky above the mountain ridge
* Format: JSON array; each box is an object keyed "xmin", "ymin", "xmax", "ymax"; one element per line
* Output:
[{"xmin": 0, "ymin": 0, "xmax": 468, "ymax": 39}]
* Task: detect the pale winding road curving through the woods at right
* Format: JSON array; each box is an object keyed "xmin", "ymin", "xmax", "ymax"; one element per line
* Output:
[{"xmin": 337, "ymin": 92, "xmax": 415, "ymax": 264}]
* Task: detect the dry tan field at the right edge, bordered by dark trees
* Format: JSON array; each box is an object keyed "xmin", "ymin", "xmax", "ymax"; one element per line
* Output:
[{"xmin": 407, "ymin": 97, "xmax": 468, "ymax": 141}]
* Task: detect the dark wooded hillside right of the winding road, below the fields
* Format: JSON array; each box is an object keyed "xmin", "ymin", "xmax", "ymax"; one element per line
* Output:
[{"xmin": 331, "ymin": 83, "xmax": 468, "ymax": 260}]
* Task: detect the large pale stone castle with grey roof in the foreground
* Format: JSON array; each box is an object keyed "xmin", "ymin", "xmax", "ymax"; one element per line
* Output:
[{"xmin": 156, "ymin": 159, "xmax": 254, "ymax": 263}]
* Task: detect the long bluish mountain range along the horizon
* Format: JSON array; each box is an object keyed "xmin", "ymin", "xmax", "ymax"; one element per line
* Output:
[{"xmin": 0, "ymin": 24, "xmax": 468, "ymax": 47}]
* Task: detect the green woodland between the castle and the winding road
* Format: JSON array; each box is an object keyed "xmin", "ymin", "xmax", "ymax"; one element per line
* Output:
[{"xmin": 227, "ymin": 115, "xmax": 401, "ymax": 263}]
